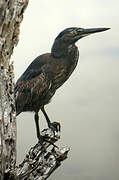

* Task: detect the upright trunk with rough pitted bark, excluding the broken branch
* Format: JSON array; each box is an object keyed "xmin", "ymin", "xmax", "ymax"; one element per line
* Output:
[{"xmin": 0, "ymin": 0, "xmax": 28, "ymax": 179}]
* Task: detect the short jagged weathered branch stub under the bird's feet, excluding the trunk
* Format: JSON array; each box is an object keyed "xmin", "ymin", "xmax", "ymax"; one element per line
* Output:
[{"xmin": 16, "ymin": 129, "xmax": 69, "ymax": 180}]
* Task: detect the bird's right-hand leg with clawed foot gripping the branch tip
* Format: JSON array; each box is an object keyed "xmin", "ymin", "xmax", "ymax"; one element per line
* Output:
[{"xmin": 41, "ymin": 106, "xmax": 61, "ymax": 135}]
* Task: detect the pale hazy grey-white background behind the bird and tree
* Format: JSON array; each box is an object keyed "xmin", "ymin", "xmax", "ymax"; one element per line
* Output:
[{"xmin": 13, "ymin": 0, "xmax": 119, "ymax": 180}]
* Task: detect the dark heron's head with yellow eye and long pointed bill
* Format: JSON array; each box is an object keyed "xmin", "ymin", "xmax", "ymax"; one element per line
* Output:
[{"xmin": 52, "ymin": 27, "xmax": 110, "ymax": 56}]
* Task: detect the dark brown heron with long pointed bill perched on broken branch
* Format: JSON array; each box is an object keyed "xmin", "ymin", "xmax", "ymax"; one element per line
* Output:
[{"xmin": 15, "ymin": 27, "xmax": 110, "ymax": 141}]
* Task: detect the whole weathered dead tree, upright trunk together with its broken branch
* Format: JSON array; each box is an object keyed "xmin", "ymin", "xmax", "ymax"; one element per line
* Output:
[{"xmin": 0, "ymin": 0, "xmax": 69, "ymax": 180}]
